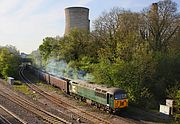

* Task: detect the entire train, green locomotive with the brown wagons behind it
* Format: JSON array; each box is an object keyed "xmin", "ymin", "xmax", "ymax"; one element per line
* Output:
[{"xmin": 27, "ymin": 66, "xmax": 128, "ymax": 113}]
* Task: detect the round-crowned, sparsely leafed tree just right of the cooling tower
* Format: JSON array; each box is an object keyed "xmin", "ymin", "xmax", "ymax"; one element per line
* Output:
[{"xmin": 93, "ymin": 8, "xmax": 143, "ymax": 62}]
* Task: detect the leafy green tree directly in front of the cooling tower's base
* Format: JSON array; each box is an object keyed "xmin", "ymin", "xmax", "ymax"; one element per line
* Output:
[{"xmin": 59, "ymin": 29, "xmax": 90, "ymax": 62}]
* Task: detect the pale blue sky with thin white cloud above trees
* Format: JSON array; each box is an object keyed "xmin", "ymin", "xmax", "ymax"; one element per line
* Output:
[{"xmin": 0, "ymin": 0, "xmax": 180, "ymax": 53}]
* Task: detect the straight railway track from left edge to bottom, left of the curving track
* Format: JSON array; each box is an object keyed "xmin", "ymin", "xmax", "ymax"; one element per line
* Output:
[{"xmin": 0, "ymin": 84, "xmax": 71, "ymax": 124}]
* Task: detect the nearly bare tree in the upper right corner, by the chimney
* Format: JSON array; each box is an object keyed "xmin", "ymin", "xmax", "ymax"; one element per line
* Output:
[{"xmin": 142, "ymin": 0, "xmax": 180, "ymax": 51}]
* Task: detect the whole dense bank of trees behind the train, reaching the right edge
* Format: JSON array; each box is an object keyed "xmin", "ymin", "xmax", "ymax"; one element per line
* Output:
[{"xmin": 35, "ymin": 0, "xmax": 180, "ymax": 106}]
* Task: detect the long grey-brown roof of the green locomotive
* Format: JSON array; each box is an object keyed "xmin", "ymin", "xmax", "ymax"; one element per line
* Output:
[{"xmin": 71, "ymin": 80, "xmax": 125, "ymax": 94}]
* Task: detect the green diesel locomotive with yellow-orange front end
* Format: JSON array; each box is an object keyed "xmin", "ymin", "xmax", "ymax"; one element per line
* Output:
[{"xmin": 69, "ymin": 80, "xmax": 128, "ymax": 112}]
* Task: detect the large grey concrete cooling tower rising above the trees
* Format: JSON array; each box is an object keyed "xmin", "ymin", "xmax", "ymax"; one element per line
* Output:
[{"xmin": 65, "ymin": 7, "xmax": 90, "ymax": 35}]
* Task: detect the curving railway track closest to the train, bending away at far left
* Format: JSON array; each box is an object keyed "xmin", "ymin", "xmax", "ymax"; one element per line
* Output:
[{"xmin": 19, "ymin": 68, "xmax": 111, "ymax": 124}]
